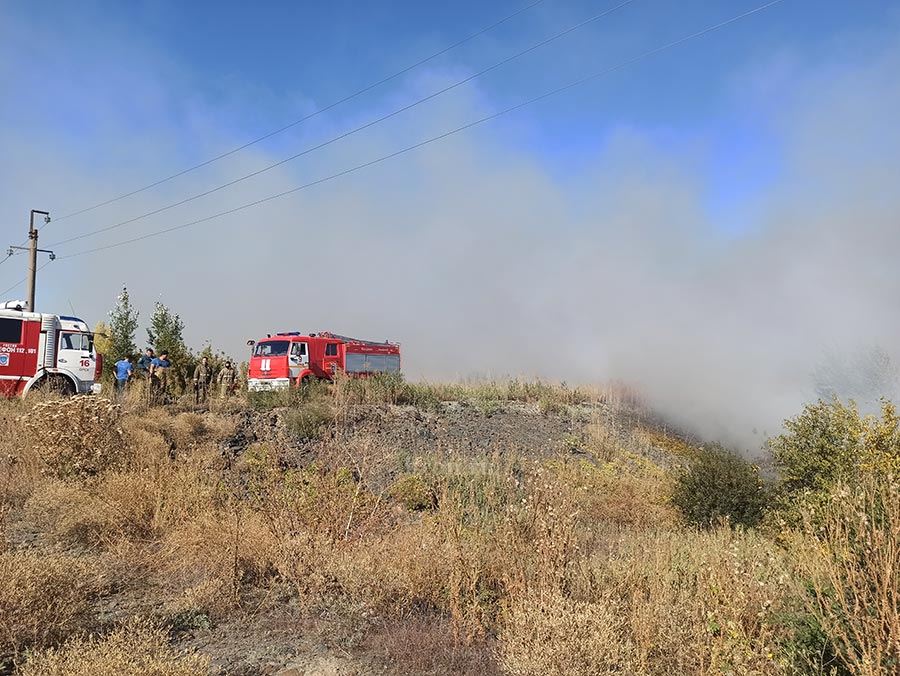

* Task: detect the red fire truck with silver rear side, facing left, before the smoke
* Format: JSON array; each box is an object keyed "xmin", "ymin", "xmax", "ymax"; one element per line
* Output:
[{"xmin": 247, "ymin": 331, "xmax": 400, "ymax": 392}]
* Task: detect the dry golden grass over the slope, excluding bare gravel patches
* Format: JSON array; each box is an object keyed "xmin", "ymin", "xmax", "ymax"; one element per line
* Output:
[{"xmin": 0, "ymin": 388, "xmax": 888, "ymax": 676}]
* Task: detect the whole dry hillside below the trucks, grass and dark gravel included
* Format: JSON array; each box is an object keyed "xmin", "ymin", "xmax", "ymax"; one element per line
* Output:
[{"xmin": 0, "ymin": 386, "xmax": 804, "ymax": 676}]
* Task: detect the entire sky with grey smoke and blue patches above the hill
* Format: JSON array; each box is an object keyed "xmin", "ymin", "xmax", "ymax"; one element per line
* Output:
[{"xmin": 0, "ymin": 0, "xmax": 900, "ymax": 444}]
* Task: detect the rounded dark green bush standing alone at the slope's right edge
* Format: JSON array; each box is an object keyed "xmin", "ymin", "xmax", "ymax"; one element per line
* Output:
[{"xmin": 672, "ymin": 445, "xmax": 767, "ymax": 528}]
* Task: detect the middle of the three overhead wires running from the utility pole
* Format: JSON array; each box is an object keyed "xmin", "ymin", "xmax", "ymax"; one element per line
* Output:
[{"xmin": 49, "ymin": 0, "xmax": 635, "ymax": 247}]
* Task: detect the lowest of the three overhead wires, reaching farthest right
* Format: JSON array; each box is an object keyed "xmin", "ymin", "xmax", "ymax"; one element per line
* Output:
[{"xmin": 58, "ymin": 0, "xmax": 783, "ymax": 259}]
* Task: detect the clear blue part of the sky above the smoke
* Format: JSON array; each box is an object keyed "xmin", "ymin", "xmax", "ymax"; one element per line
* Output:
[{"xmin": 0, "ymin": 0, "xmax": 898, "ymax": 228}]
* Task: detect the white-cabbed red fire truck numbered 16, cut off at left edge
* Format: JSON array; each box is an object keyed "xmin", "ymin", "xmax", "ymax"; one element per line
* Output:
[{"xmin": 0, "ymin": 301, "xmax": 103, "ymax": 397}]
